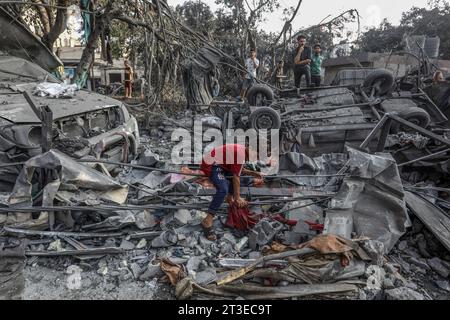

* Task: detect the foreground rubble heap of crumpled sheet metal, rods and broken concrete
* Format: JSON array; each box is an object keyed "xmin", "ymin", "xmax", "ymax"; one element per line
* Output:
[{"xmin": 0, "ymin": 112, "xmax": 450, "ymax": 300}]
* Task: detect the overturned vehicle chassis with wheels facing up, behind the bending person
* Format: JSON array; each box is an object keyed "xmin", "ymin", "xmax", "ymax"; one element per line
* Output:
[{"xmin": 210, "ymin": 70, "xmax": 448, "ymax": 155}]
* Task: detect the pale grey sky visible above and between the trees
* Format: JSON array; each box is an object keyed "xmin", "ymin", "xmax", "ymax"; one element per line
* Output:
[{"xmin": 168, "ymin": 0, "xmax": 450, "ymax": 32}]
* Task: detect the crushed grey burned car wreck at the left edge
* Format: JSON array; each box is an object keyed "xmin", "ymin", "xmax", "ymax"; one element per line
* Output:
[{"xmin": 0, "ymin": 56, "xmax": 139, "ymax": 191}]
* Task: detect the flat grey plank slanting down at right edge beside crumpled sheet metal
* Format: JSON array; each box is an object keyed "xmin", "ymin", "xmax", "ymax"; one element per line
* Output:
[{"xmin": 405, "ymin": 191, "xmax": 450, "ymax": 251}]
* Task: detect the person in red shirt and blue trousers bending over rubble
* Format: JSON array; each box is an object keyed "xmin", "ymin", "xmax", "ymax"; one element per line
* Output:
[{"xmin": 201, "ymin": 144, "xmax": 262, "ymax": 240}]
